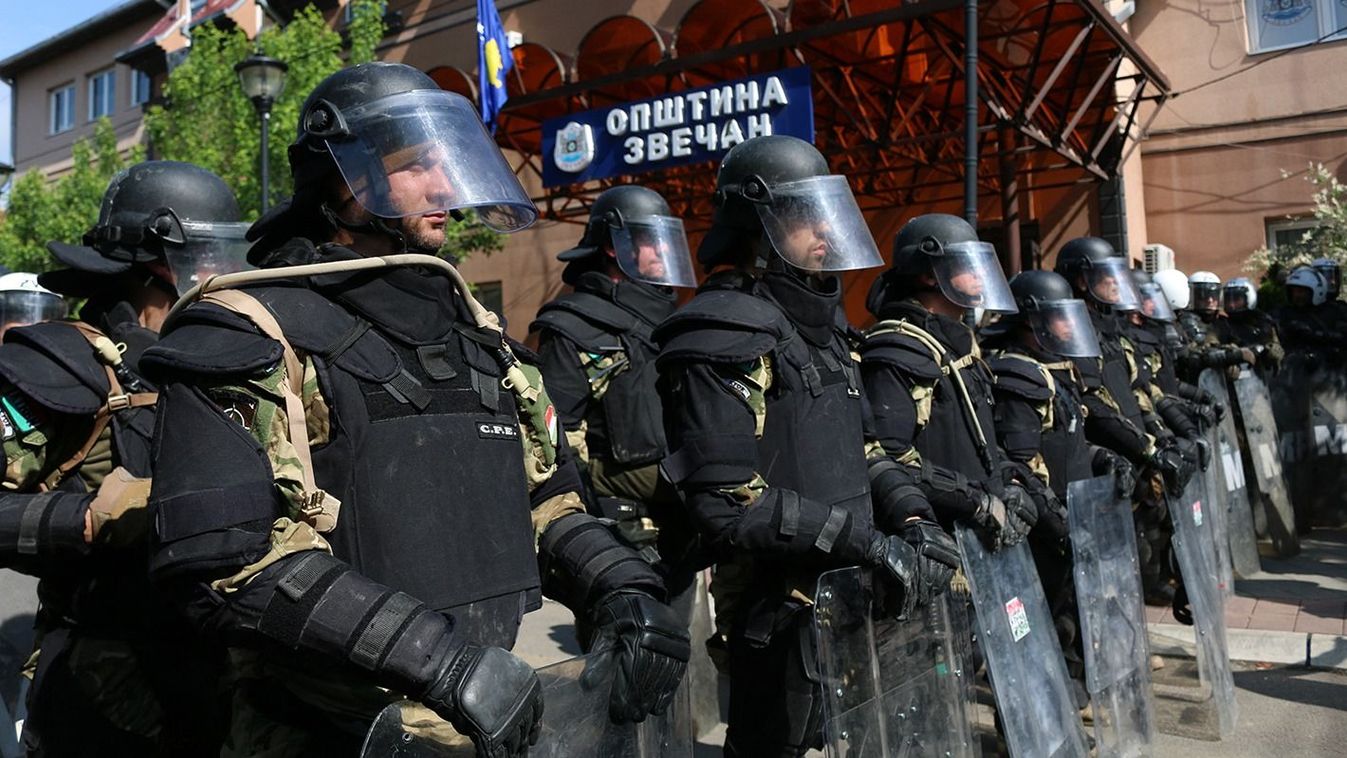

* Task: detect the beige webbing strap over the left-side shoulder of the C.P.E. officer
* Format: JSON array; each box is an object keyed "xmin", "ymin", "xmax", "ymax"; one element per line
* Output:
[{"xmin": 201, "ymin": 289, "xmax": 341, "ymax": 532}]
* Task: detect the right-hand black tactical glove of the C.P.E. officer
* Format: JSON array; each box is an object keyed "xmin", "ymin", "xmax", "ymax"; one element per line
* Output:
[{"xmin": 594, "ymin": 590, "xmax": 692, "ymax": 723}]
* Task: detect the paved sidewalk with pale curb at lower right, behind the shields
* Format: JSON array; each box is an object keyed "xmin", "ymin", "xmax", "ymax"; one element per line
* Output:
[{"xmin": 1146, "ymin": 529, "xmax": 1347, "ymax": 669}]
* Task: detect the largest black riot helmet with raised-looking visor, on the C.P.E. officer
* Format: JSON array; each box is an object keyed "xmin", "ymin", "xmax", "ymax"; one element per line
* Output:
[{"xmin": 249, "ymin": 62, "xmax": 537, "ymax": 254}]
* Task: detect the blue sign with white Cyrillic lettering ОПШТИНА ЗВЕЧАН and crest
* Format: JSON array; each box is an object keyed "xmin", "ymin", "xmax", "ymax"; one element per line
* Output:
[{"xmin": 543, "ymin": 66, "xmax": 814, "ymax": 187}]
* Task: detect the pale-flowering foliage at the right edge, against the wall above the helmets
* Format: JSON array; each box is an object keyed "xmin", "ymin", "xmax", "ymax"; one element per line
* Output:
[{"xmin": 1245, "ymin": 163, "xmax": 1347, "ymax": 307}]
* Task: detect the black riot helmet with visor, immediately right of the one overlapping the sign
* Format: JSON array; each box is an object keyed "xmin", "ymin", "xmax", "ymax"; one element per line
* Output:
[{"xmin": 866, "ymin": 213, "xmax": 1016, "ymax": 314}]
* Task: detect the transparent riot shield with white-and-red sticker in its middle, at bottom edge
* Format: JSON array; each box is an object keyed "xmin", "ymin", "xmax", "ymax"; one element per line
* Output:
[{"xmin": 955, "ymin": 525, "xmax": 1087, "ymax": 758}]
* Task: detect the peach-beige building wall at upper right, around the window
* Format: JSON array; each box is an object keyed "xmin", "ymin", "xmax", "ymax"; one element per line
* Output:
[{"xmin": 1129, "ymin": 0, "xmax": 1347, "ymax": 277}]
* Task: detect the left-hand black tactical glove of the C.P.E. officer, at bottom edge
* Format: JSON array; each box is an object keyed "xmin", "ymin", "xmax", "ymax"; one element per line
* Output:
[{"xmin": 420, "ymin": 645, "xmax": 543, "ymax": 758}]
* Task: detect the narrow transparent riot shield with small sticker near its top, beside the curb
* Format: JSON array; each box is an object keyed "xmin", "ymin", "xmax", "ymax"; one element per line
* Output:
[{"xmin": 1156, "ymin": 478, "xmax": 1239, "ymax": 739}]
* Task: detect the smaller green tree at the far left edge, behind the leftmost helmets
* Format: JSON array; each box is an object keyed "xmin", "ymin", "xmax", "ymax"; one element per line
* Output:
[{"xmin": 0, "ymin": 118, "xmax": 144, "ymax": 272}]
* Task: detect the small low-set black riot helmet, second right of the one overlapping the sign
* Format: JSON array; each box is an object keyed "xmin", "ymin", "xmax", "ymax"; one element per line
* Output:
[{"xmin": 1010, "ymin": 271, "xmax": 1099, "ymax": 358}]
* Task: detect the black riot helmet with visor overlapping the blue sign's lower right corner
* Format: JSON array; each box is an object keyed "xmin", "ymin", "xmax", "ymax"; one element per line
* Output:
[{"xmin": 696, "ymin": 135, "xmax": 884, "ymax": 272}]
